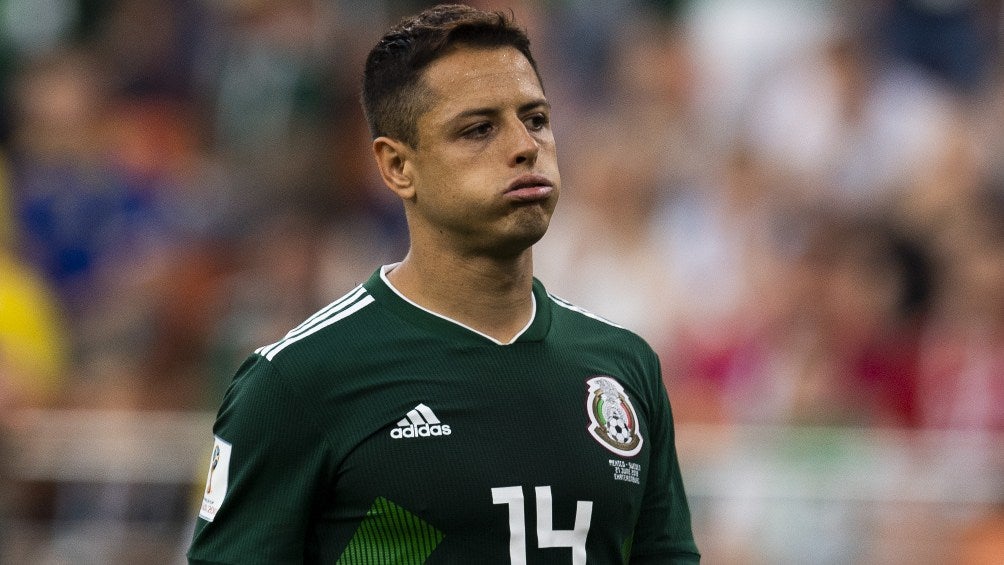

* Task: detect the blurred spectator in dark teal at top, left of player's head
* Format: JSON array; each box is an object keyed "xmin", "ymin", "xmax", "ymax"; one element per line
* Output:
[{"xmin": 203, "ymin": 0, "xmax": 335, "ymax": 178}]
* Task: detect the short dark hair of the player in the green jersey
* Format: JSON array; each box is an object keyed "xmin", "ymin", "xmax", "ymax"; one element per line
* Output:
[{"xmin": 362, "ymin": 4, "xmax": 543, "ymax": 147}]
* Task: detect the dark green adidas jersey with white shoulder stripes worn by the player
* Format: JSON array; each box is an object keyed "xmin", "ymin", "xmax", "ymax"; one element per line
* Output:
[{"xmin": 189, "ymin": 267, "xmax": 699, "ymax": 565}]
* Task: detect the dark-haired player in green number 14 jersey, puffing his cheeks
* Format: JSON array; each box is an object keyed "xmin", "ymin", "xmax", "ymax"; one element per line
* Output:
[{"xmin": 189, "ymin": 6, "xmax": 699, "ymax": 564}]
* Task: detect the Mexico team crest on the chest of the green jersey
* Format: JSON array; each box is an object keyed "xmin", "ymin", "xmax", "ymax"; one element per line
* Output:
[{"xmin": 585, "ymin": 375, "xmax": 642, "ymax": 457}]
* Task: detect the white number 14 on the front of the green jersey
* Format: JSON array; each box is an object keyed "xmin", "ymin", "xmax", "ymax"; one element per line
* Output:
[{"xmin": 492, "ymin": 487, "xmax": 592, "ymax": 565}]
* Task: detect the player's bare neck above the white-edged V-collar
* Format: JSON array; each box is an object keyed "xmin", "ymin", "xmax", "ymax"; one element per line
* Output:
[{"xmin": 388, "ymin": 246, "xmax": 533, "ymax": 343}]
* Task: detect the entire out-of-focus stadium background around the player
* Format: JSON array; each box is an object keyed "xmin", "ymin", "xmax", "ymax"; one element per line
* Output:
[{"xmin": 0, "ymin": 0, "xmax": 1004, "ymax": 565}]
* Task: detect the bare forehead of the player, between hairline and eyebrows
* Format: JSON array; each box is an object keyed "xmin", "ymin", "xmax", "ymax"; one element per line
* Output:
[{"xmin": 423, "ymin": 46, "xmax": 544, "ymax": 114}]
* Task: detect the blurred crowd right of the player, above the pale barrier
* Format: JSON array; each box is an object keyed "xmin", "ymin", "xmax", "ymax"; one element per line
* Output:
[{"xmin": 536, "ymin": 1, "xmax": 1004, "ymax": 431}]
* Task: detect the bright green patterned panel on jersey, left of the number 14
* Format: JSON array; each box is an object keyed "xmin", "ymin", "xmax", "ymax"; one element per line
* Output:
[{"xmin": 337, "ymin": 497, "xmax": 443, "ymax": 565}]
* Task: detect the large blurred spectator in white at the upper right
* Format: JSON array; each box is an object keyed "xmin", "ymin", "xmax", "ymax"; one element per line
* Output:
[{"xmin": 744, "ymin": 24, "xmax": 951, "ymax": 210}]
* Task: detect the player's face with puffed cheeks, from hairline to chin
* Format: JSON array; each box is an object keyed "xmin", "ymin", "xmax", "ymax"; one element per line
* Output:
[{"xmin": 410, "ymin": 47, "xmax": 560, "ymax": 257}]
